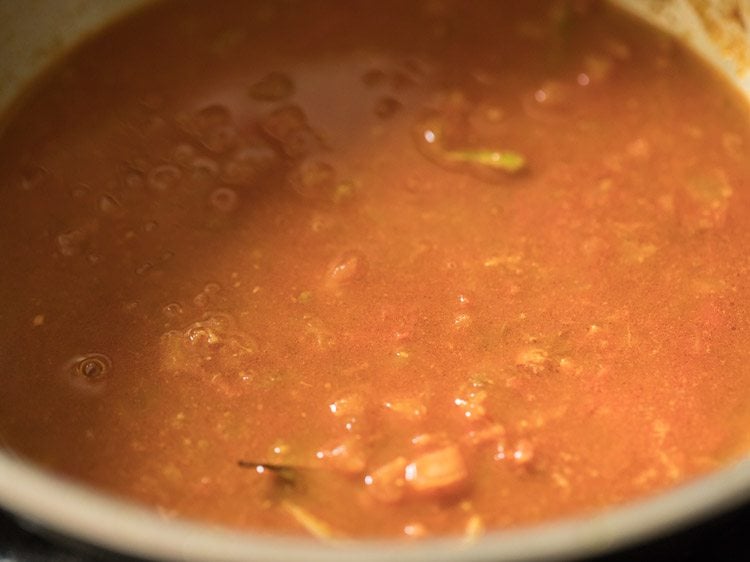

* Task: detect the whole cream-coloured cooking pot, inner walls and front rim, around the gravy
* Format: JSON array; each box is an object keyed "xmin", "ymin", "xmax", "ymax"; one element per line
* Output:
[{"xmin": 0, "ymin": 0, "xmax": 750, "ymax": 561}]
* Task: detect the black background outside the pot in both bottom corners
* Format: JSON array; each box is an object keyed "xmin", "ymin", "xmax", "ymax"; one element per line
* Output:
[{"xmin": 0, "ymin": 506, "xmax": 750, "ymax": 562}]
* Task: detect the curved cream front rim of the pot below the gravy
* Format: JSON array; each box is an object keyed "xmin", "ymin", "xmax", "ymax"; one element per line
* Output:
[{"xmin": 0, "ymin": 451, "xmax": 750, "ymax": 562}]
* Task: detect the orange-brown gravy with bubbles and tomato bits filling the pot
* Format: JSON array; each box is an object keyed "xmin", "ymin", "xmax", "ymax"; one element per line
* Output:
[{"xmin": 0, "ymin": 0, "xmax": 750, "ymax": 538}]
